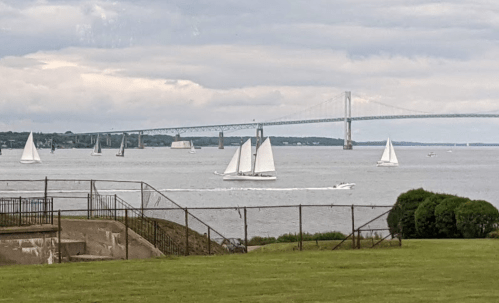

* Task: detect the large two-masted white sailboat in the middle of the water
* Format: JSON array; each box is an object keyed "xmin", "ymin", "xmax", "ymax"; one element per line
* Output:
[{"xmin": 223, "ymin": 138, "xmax": 277, "ymax": 181}]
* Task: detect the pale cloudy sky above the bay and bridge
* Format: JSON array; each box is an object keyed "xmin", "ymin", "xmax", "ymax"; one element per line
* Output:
[{"xmin": 0, "ymin": 0, "xmax": 499, "ymax": 142}]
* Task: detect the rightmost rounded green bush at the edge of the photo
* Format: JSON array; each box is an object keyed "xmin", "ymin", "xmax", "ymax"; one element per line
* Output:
[{"xmin": 455, "ymin": 200, "xmax": 499, "ymax": 238}]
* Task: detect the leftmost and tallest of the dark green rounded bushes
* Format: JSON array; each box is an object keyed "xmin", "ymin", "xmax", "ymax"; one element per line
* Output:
[{"xmin": 387, "ymin": 188, "xmax": 434, "ymax": 239}]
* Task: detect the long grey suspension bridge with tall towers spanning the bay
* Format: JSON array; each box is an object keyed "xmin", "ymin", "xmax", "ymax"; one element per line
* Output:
[{"xmin": 76, "ymin": 91, "xmax": 499, "ymax": 150}]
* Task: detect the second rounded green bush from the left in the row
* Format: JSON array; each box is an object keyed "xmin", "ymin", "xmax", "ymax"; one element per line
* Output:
[{"xmin": 414, "ymin": 194, "xmax": 452, "ymax": 238}]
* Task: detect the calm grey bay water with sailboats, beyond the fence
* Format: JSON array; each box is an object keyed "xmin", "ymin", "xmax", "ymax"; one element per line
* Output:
[{"xmin": 0, "ymin": 146, "xmax": 499, "ymax": 236}]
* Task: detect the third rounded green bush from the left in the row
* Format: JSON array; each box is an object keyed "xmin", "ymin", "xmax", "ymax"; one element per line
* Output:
[{"xmin": 435, "ymin": 197, "xmax": 470, "ymax": 238}]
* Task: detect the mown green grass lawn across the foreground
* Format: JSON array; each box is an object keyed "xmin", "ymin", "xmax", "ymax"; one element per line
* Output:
[{"xmin": 0, "ymin": 239, "xmax": 499, "ymax": 302}]
